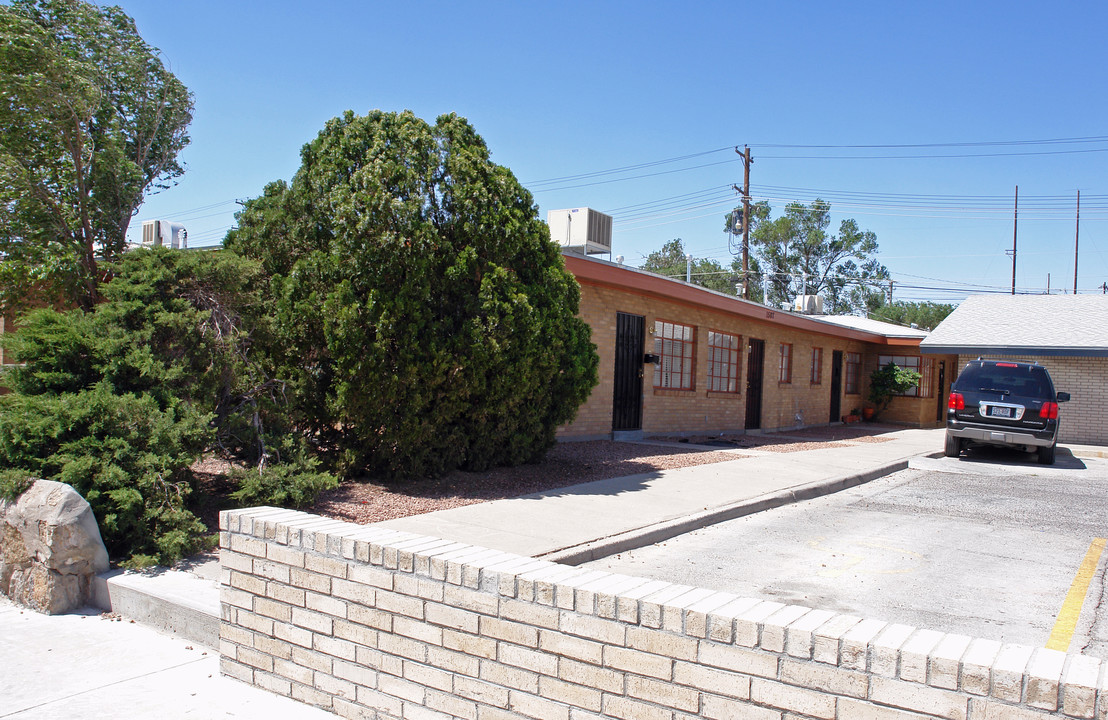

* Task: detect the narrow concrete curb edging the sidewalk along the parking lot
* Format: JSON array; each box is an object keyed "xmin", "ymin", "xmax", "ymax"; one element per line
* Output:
[{"xmin": 536, "ymin": 460, "xmax": 909, "ymax": 565}]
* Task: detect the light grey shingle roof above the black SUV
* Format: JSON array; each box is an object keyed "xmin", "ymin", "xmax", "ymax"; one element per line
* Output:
[{"xmin": 920, "ymin": 295, "xmax": 1108, "ymax": 357}]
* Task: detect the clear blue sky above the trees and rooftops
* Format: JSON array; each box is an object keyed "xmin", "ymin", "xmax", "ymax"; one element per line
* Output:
[{"xmin": 120, "ymin": 0, "xmax": 1108, "ymax": 301}]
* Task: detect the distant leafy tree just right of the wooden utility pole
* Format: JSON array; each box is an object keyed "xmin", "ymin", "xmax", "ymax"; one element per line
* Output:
[{"xmin": 750, "ymin": 198, "xmax": 889, "ymax": 313}]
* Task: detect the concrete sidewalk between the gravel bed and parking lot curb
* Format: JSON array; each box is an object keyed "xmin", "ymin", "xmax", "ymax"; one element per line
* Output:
[{"xmin": 381, "ymin": 429, "xmax": 945, "ymax": 565}]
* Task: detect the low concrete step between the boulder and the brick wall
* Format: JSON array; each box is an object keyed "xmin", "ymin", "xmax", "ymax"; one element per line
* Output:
[{"xmin": 93, "ymin": 563, "xmax": 219, "ymax": 649}]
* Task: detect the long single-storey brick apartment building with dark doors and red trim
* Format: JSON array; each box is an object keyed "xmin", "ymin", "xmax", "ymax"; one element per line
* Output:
[{"xmin": 560, "ymin": 251, "xmax": 957, "ymax": 440}]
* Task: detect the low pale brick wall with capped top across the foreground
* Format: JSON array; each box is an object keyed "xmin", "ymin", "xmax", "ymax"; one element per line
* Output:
[{"xmin": 220, "ymin": 507, "xmax": 1108, "ymax": 720}]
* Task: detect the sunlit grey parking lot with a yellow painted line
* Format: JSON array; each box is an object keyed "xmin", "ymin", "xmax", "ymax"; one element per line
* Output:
[{"xmin": 588, "ymin": 449, "xmax": 1108, "ymax": 658}]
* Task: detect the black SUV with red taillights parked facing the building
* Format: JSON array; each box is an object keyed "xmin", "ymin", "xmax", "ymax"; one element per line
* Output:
[{"xmin": 945, "ymin": 358, "xmax": 1069, "ymax": 465}]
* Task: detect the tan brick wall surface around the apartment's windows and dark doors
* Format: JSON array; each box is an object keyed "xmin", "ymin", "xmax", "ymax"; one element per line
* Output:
[{"xmin": 558, "ymin": 285, "xmax": 954, "ymax": 439}]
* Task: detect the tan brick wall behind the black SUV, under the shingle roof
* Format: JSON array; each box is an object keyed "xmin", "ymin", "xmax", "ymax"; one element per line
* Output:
[{"xmin": 958, "ymin": 356, "xmax": 1108, "ymax": 445}]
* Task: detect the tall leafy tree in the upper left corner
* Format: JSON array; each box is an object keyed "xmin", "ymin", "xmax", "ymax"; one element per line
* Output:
[{"xmin": 0, "ymin": 0, "xmax": 193, "ymax": 308}]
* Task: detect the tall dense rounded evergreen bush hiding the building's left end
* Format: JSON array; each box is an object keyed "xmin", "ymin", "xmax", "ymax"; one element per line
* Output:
[{"xmin": 224, "ymin": 112, "xmax": 597, "ymax": 476}]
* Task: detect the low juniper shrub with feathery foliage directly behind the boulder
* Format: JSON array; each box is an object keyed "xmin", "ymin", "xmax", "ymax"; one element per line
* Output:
[{"xmin": 0, "ymin": 382, "xmax": 211, "ymax": 565}]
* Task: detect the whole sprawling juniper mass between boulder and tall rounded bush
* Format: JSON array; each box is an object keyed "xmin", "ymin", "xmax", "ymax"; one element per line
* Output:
[{"xmin": 0, "ymin": 249, "xmax": 336, "ymax": 565}]
